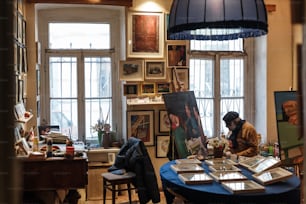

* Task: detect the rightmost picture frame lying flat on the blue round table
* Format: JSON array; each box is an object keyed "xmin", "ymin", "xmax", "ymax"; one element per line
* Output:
[{"xmin": 252, "ymin": 167, "xmax": 293, "ymax": 185}]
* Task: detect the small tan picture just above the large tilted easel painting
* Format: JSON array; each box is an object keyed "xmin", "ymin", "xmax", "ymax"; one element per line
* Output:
[{"xmin": 172, "ymin": 68, "xmax": 189, "ymax": 91}]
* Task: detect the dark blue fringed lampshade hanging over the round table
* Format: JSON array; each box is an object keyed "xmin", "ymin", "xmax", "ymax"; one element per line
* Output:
[{"xmin": 168, "ymin": 0, "xmax": 268, "ymax": 40}]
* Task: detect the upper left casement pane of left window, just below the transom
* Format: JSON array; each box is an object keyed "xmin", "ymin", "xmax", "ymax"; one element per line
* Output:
[{"xmin": 49, "ymin": 57, "xmax": 77, "ymax": 98}]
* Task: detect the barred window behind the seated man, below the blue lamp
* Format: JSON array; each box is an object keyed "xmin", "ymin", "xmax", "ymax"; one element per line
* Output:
[{"xmin": 190, "ymin": 39, "xmax": 248, "ymax": 137}]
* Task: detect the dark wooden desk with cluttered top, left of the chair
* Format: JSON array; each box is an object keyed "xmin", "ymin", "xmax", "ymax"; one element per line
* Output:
[{"xmin": 22, "ymin": 157, "xmax": 88, "ymax": 191}]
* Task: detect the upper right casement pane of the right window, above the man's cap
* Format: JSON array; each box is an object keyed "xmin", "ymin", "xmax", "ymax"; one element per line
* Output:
[{"xmin": 220, "ymin": 59, "xmax": 244, "ymax": 97}]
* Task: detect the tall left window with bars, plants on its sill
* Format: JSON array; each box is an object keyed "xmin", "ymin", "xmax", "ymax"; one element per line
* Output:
[{"xmin": 44, "ymin": 19, "xmax": 115, "ymax": 140}]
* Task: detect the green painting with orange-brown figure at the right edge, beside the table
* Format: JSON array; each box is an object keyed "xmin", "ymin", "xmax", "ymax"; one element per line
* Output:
[{"xmin": 274, "ymin": 91, "xmax": 304, "ymax": 160}]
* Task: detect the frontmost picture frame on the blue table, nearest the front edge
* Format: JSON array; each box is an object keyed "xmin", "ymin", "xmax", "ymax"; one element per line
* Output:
[{"xmin": 221, "ymin": 180, "xmax": 265, "ymax": 194}]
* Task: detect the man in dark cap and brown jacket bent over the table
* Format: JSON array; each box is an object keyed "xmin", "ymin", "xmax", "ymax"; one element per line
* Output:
[{"xmin": 223, "ymin": 111, "xmax": 259, "ymax": 157}]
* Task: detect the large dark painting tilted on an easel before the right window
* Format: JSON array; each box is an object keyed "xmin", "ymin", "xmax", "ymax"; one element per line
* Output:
[{"xmin": 163, "ymin": 91, "xmax": 207, "ymax": 159}]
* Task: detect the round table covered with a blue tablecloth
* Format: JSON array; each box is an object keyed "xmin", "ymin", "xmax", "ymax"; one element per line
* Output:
[{"xmin": 160, "ymin": 161, "xmax": 301, "ymax": 204}]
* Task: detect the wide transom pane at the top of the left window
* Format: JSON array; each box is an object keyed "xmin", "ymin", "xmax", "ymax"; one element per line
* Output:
[{"xmin": 49, "ymin": 23, "xmax": 110, "ymax": 49}]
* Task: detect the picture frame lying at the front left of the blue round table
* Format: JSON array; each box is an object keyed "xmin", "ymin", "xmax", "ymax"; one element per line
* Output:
[{"xmin": 178, "ymin": 172, "xmax": 213, "ymax": 185}]
